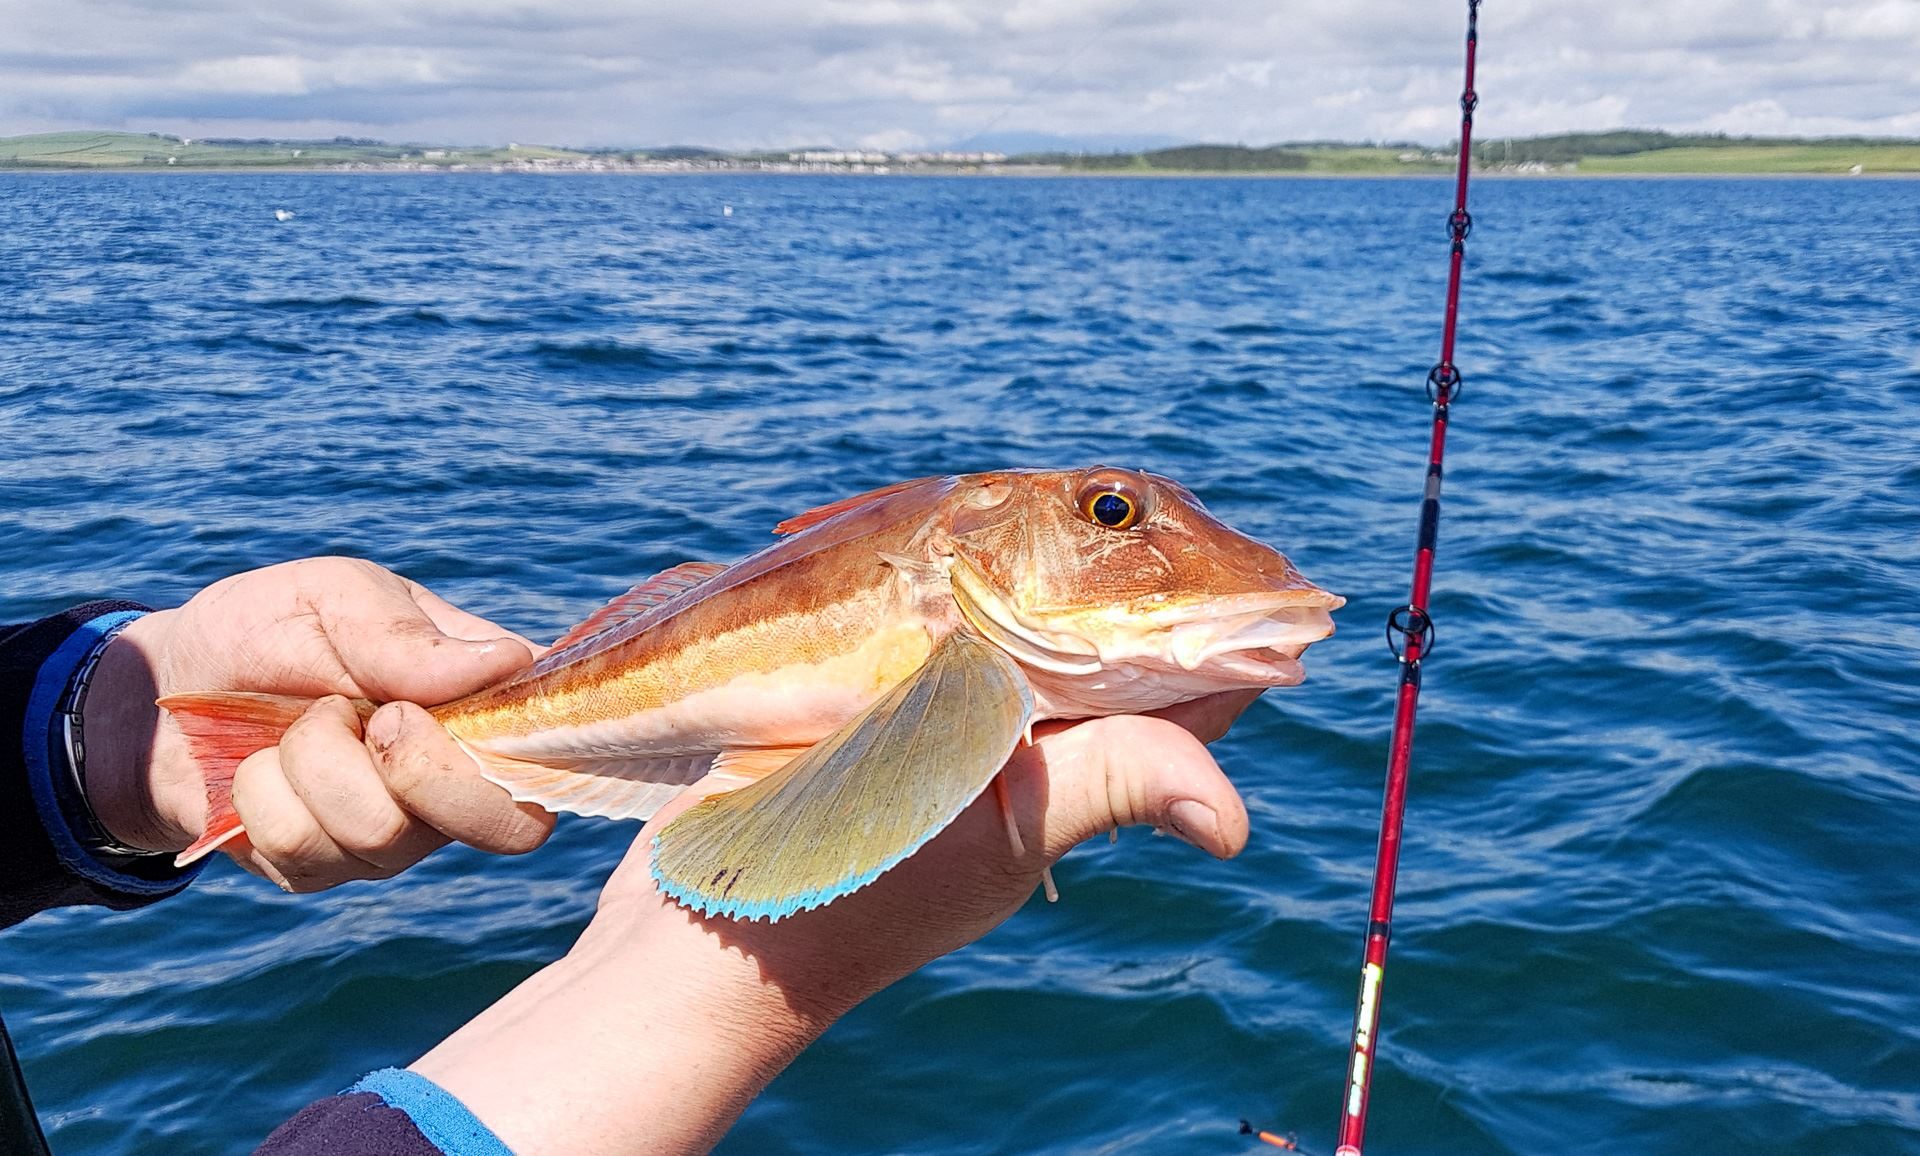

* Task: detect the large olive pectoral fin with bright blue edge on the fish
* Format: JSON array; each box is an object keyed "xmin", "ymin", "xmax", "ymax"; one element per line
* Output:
[{"xmin": 653, "ymin": 632, "xmax": 1033, "ymax": 920}]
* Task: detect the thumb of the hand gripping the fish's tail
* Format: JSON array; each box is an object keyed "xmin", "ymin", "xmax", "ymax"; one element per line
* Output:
[{"xmin": 321, "ymin": 584, "xmax": 534, "ymax": 707}]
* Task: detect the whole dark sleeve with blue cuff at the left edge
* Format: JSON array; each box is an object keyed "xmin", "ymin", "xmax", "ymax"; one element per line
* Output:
[{"xmin": 0, "ymin": 601, "xmax": 198, "ymax": 927}]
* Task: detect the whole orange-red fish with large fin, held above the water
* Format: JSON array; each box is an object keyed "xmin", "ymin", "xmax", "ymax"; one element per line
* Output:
[{"xmin": 159, "ymin": 467, "xmax": 1344, "ymax": 920}]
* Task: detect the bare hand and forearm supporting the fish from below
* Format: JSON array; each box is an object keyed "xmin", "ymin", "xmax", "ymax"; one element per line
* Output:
[{"xmin": 413, "ymin": 691, "xmax": 1258, "ymax": 1156}]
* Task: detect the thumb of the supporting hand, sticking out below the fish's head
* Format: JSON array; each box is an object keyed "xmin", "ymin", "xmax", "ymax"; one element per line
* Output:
[{"xmin": 1008, "ymin": 714, "xmax": 1246, "ymax": 860}]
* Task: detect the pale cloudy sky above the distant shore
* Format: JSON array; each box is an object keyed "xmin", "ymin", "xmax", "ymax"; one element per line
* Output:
[{"xmin": 0, "ymin": 0, "xmax": 1920, "ymax": 148}]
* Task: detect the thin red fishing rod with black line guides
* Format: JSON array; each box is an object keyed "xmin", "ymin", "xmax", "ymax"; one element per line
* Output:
[{"xmin": 1242, "ymin": 0, "xmax": 1480, "ymax": 1156}]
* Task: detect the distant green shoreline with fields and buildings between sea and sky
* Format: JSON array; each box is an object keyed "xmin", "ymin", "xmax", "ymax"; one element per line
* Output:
[{"xmin": 0, "ymin": 131, "xmax": 1920, "ymax": 175}]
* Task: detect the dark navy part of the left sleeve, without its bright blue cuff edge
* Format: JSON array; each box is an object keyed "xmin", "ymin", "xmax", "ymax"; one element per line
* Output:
[{"xmin": 0, "ymin": 601, "xmax": 194, "ymax": 927}]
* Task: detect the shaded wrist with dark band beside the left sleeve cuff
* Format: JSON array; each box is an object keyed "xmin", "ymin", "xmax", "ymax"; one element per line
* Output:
[{"xmin": 81, "ymin": 611, "xmax": 192, "ymax": 851}]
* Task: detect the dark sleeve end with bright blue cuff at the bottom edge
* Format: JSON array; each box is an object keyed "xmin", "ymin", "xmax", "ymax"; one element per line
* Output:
[{"xmin": 253, "ymin": 1068, "xmax": 513, "ymax": 1156}]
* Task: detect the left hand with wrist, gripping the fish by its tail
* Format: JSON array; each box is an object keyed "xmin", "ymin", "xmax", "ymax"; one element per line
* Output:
[{"xmin": 83, "ymin": 557, "xmax": 553, "ymax": 891}]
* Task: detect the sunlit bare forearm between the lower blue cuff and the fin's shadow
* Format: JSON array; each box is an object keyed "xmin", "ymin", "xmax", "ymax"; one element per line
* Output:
[{"xmin": 413, "ymin": 897, "xmax": 856, "ymax": 1156}]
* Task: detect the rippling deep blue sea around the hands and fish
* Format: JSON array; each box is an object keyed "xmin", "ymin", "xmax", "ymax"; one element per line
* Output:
[{"xmin": 0, "ymin": 173, "xmax": 1920, "ymax": 1156}]
